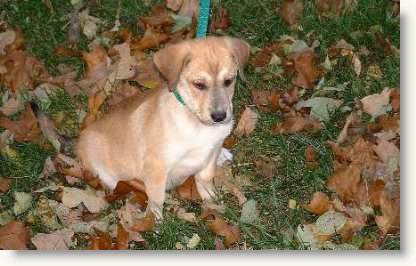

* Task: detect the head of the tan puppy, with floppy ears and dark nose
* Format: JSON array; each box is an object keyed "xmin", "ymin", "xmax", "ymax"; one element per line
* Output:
[{"xmin": 153, "ymin": 37, "xmax": 250, "ymax": 125}]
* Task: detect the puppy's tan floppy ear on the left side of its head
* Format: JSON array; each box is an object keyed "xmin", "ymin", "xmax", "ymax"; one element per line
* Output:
[{"xmin": 153, "ymin": 42, "xmax": 189, "ymax": 91}]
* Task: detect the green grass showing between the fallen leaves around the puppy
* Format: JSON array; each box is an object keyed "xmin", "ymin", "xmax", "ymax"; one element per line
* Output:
[{"xmin": 0, "ymin": 0, "xmax": 400, "ymax": 249}]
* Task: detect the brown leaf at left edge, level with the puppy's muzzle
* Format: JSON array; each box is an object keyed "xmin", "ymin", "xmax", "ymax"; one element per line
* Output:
[{"xmin": 0, "ymin": 105, "xmax": 41, "ymax": 142}]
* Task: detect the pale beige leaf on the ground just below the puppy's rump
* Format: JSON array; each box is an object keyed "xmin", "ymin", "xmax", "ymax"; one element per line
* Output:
[{"xmin": 62, "ymin": 187, "xmax": 108, "ymax": 213}]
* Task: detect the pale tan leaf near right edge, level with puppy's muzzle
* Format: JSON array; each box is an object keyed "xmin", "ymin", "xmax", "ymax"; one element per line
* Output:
[{"xmin": 361, "ymin": 88, "xmax": 391, "ymax": 117}]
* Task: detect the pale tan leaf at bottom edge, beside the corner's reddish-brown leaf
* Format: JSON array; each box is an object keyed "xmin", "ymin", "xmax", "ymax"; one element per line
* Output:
[{"xmin": 31, "ymin": 228, "xmax": 74, "ymax": 250}]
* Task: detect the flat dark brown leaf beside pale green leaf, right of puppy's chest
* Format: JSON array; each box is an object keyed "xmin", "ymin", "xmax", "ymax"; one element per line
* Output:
[{"xmin": 272, "ymin": 113, "xmax": 324, "ymax": 134}]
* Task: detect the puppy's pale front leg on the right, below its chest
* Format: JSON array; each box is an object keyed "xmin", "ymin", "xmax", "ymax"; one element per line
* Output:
[{"xmin": 195, "ymin": 147, "xmax": 221, "ymax": 201}]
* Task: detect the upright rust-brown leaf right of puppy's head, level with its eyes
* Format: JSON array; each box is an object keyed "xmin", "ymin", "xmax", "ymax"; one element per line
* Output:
[{"xmin": 288, "ymin": 50, "xmax": 321, "ymax": 89}]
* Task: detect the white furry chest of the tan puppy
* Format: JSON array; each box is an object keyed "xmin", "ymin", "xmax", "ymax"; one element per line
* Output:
[{"xmin": 165, "ymin": 123, "xmax": 232, "ymax": 183}]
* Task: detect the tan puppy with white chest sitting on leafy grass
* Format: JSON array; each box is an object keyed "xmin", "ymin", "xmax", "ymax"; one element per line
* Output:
[{"xmin": 77, "ymin": 37, "xmax": 250, "ymax": 218}]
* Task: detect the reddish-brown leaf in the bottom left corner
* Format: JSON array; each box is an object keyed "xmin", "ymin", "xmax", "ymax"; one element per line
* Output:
[{"xmin": 0, "ymin": 221, "xmax": 29, "ymax": 250}]
